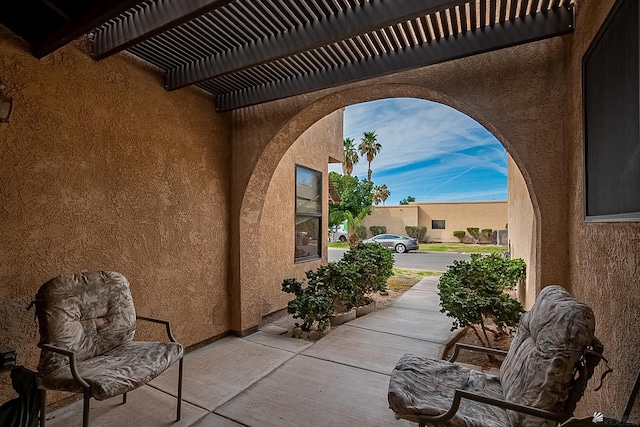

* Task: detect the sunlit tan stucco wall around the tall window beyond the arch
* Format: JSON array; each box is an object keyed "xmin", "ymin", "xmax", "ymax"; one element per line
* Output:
[{"xmin": 258, "ymin": 110, "xmax": 343, "ymax": 321}]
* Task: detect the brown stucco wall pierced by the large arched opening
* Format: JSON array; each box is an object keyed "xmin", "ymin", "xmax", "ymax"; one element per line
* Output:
[{"xmin": 230, "ymin": 38, "xmax": 568, "ymax": 332}]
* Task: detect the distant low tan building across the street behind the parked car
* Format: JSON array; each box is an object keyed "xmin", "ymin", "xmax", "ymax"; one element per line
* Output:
[{"xmin": 362, "ymin": 201, "xmax": 507, "ymax": 243}]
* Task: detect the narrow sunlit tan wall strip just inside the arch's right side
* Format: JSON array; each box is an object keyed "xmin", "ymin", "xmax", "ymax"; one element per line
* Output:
[{"xmin": 507, "ymin": 157, "xmax": 536, "ymax": 309}]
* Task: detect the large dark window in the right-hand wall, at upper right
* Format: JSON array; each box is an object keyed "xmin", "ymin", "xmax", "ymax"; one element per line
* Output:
[{"xmin": 582, "ymin": 0, "xmax": 640, "ymax": 221}]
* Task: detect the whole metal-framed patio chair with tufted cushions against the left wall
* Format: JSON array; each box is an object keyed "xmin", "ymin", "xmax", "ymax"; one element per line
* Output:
[{"xmin": 35, "ymin": 271, "xmax": 183, "ymax": 427}]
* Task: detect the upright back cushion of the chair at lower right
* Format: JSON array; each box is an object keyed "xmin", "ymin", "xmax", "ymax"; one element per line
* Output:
[{"xmin": 500, "ymin": 285, "xmax": 595, "ymax": 426}]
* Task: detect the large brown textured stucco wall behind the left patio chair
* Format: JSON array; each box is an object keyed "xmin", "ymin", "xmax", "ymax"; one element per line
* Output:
[{"xmin": 0, "ymin": 27, "xmax": 231, "ymax": 402}]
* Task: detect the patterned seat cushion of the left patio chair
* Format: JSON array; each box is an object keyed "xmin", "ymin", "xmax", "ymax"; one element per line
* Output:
[{"xmin": 40, "ymin": 341, "xmax": 183, "ymax": 400}]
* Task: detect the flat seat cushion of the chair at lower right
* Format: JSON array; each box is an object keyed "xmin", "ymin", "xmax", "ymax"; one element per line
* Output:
[{"xmin": 388, "ymin": 354, "xmax": 511, "ymax": 427}]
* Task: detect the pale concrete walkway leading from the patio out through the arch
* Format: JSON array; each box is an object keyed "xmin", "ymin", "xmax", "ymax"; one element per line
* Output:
[{"xmin": 47, "ymin": 277, "xmax": 453, "ymax": 427}]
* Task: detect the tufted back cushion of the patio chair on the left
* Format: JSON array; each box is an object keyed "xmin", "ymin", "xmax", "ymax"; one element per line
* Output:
[{"xmin": 36, "ymin": 271, "xmax": 136, "ymax": 376}]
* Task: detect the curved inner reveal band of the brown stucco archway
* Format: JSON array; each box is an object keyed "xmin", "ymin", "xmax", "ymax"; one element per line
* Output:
[{"xmin": 231, "ymin": 84, "xmax": 540, "ymax": 331}]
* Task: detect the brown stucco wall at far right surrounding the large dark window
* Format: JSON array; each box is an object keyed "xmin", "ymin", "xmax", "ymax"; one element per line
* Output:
[{"xmin": 566, "ymin": 0, "xmax": 640, "ymax": 423}]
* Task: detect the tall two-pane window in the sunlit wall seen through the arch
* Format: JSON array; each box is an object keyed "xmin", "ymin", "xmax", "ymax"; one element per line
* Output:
[{"xmin": 295, "ymin": 165, "xmax": 322, "ymax": 262}]
